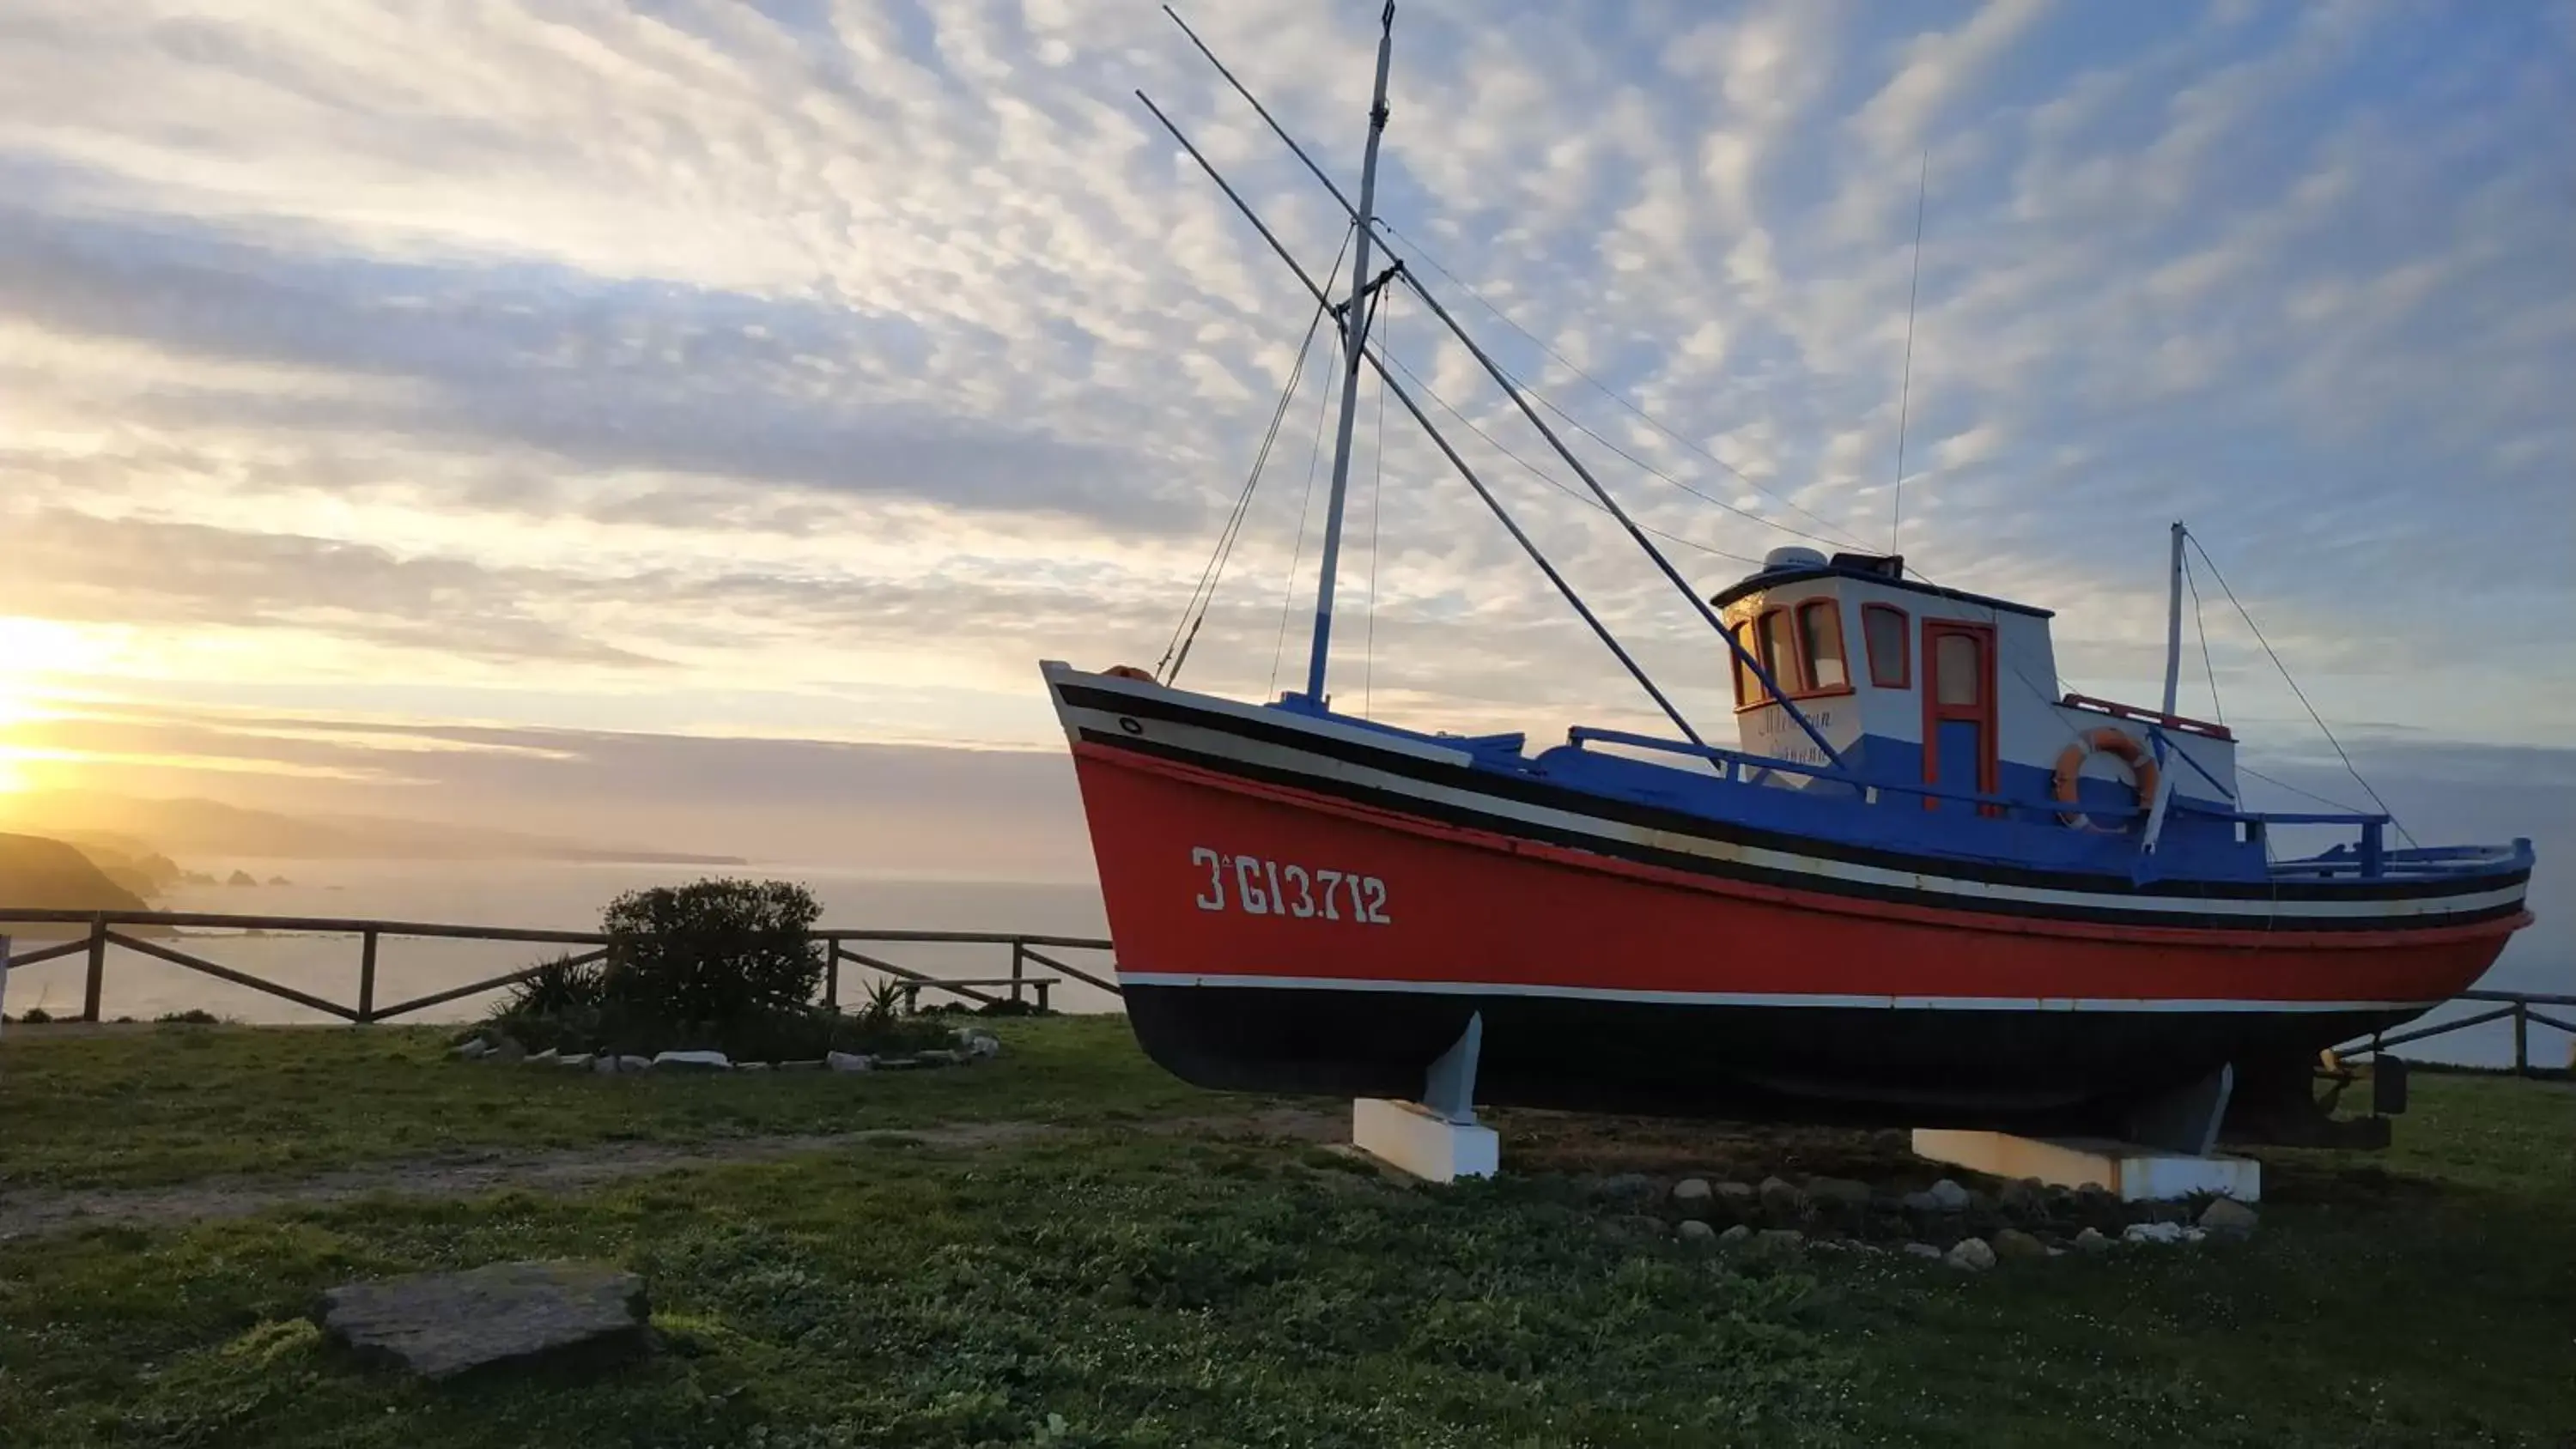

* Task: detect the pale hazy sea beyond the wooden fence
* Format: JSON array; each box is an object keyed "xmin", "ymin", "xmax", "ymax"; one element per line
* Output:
[{"xmin": 5, "ymin": 859, "xmax": 2576, "ymax": 1065}]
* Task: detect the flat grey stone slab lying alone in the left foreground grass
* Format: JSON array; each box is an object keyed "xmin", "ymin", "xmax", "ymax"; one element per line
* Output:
[{"xmin": 314, "ymin": 1264, "xmax": 647, "ymax": 1379}]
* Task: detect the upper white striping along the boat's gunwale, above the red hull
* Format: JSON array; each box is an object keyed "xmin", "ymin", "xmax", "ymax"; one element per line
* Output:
[{"xmin": 1056, "ymin": 677, "xmax": 2524, "ymax": 929}]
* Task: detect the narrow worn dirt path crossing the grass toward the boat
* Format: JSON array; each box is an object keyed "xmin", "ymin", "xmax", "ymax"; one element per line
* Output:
[{"xmin": 0, "ymin": 1109, "xmax": 1337, "ymax": 1240}]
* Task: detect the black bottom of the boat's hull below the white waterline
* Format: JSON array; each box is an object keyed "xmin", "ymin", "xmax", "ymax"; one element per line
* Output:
[{"xmin": 1126, "ymin": 983, "xmax": 2414, "ymax": 1135}]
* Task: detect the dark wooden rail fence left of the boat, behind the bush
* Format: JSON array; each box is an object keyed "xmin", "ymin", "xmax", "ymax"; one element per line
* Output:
[{"xmin": 0, "ymin": 908, "xmax": 1121, "ymax": 1027}]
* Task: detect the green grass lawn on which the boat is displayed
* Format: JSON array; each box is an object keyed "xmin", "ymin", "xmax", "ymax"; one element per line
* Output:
[{"xmin": 0, "ymin": 1019, "xmax": 2576, "ymax": 1449}]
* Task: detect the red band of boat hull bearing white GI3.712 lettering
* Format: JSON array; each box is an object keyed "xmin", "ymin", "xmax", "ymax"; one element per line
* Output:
[{"xmin": 1074, "ymin": 743, "xmax": 2530, "ymax": 1014}]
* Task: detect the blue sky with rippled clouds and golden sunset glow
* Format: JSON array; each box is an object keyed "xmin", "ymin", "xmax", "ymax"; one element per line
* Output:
[{"xmin": 0, "ymin": 0, "xmax": 2576, "ymax": 870}]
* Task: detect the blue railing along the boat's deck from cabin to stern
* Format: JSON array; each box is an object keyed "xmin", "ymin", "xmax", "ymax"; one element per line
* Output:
[{"xmin": 1566, "ymin": 725, "xmax": 2463, "ymax": 877}]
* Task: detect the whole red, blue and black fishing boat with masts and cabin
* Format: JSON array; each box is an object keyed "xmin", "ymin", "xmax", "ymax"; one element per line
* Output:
[{"xmin": 1043, "ymin": 5, "xmax": 2532, "ymax": 1150}]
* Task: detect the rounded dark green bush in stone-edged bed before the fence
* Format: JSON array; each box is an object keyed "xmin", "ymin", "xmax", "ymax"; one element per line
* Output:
[{"xmin": 600, "ymin": 880, "xmax": 822, "ymax": 1024}]
